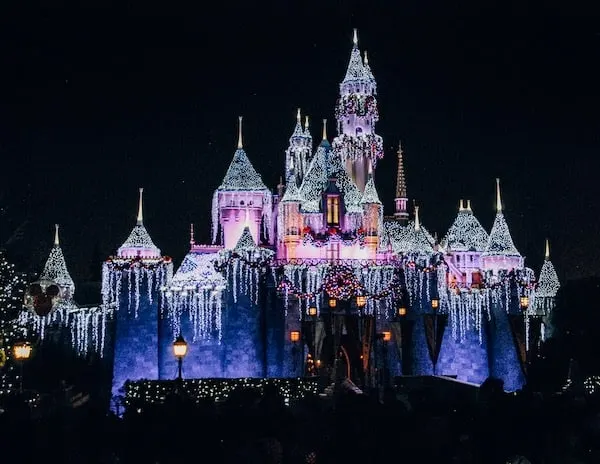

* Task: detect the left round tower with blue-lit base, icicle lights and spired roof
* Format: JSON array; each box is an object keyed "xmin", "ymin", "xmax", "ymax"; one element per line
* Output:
[{"xmin": 102, "ymin": 188, "xmax": 173, "ymax": 406}]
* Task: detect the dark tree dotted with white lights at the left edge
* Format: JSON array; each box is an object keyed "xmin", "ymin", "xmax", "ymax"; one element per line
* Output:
[{"xmin": 0, "ymin": 250, "xmax": 26, "ymax": 396}]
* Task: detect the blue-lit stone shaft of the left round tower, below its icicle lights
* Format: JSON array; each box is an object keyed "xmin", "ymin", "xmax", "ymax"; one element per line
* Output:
[{"xmin": 112, "ymin": 279, "xmax": 158, "ymax": 395}]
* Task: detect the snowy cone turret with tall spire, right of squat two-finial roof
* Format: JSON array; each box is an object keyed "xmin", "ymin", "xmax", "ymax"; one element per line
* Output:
[{"xmin": 481, "ymin": 179, "xmax": 523, "ymax": 274}]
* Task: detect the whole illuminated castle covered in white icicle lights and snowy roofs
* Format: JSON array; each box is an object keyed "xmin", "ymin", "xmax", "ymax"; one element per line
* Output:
[{"xmin": 22, "ymin": 31, "xmax": 559, "ymax": 402}]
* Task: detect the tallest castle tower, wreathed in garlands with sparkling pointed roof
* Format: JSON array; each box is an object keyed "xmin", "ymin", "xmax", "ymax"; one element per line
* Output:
[{"xmin": 332, "ymin": 29, "xmax": 383, "ymax": 192}]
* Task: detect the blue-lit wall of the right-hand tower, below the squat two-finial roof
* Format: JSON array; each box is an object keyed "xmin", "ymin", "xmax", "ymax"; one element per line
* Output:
[{"xmin": 436, "ymin": 315, "xmax": 490, "ymax": 384}]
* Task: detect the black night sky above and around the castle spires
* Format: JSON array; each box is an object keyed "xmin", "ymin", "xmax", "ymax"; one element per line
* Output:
[{"xmin": 0, "ymin": 0, "xmax": 600, "ymax": 294}]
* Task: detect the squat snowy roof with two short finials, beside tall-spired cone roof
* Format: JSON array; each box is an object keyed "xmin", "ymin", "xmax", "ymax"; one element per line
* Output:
[{"xmin": 441, "ymin": 200, "xmax": 489, "ymax": 252}]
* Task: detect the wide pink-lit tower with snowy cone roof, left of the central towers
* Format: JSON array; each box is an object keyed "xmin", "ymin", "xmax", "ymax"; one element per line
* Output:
[{"xmin": 212, "ymin": 116, "xmax": 273, "ymax": 249}]
